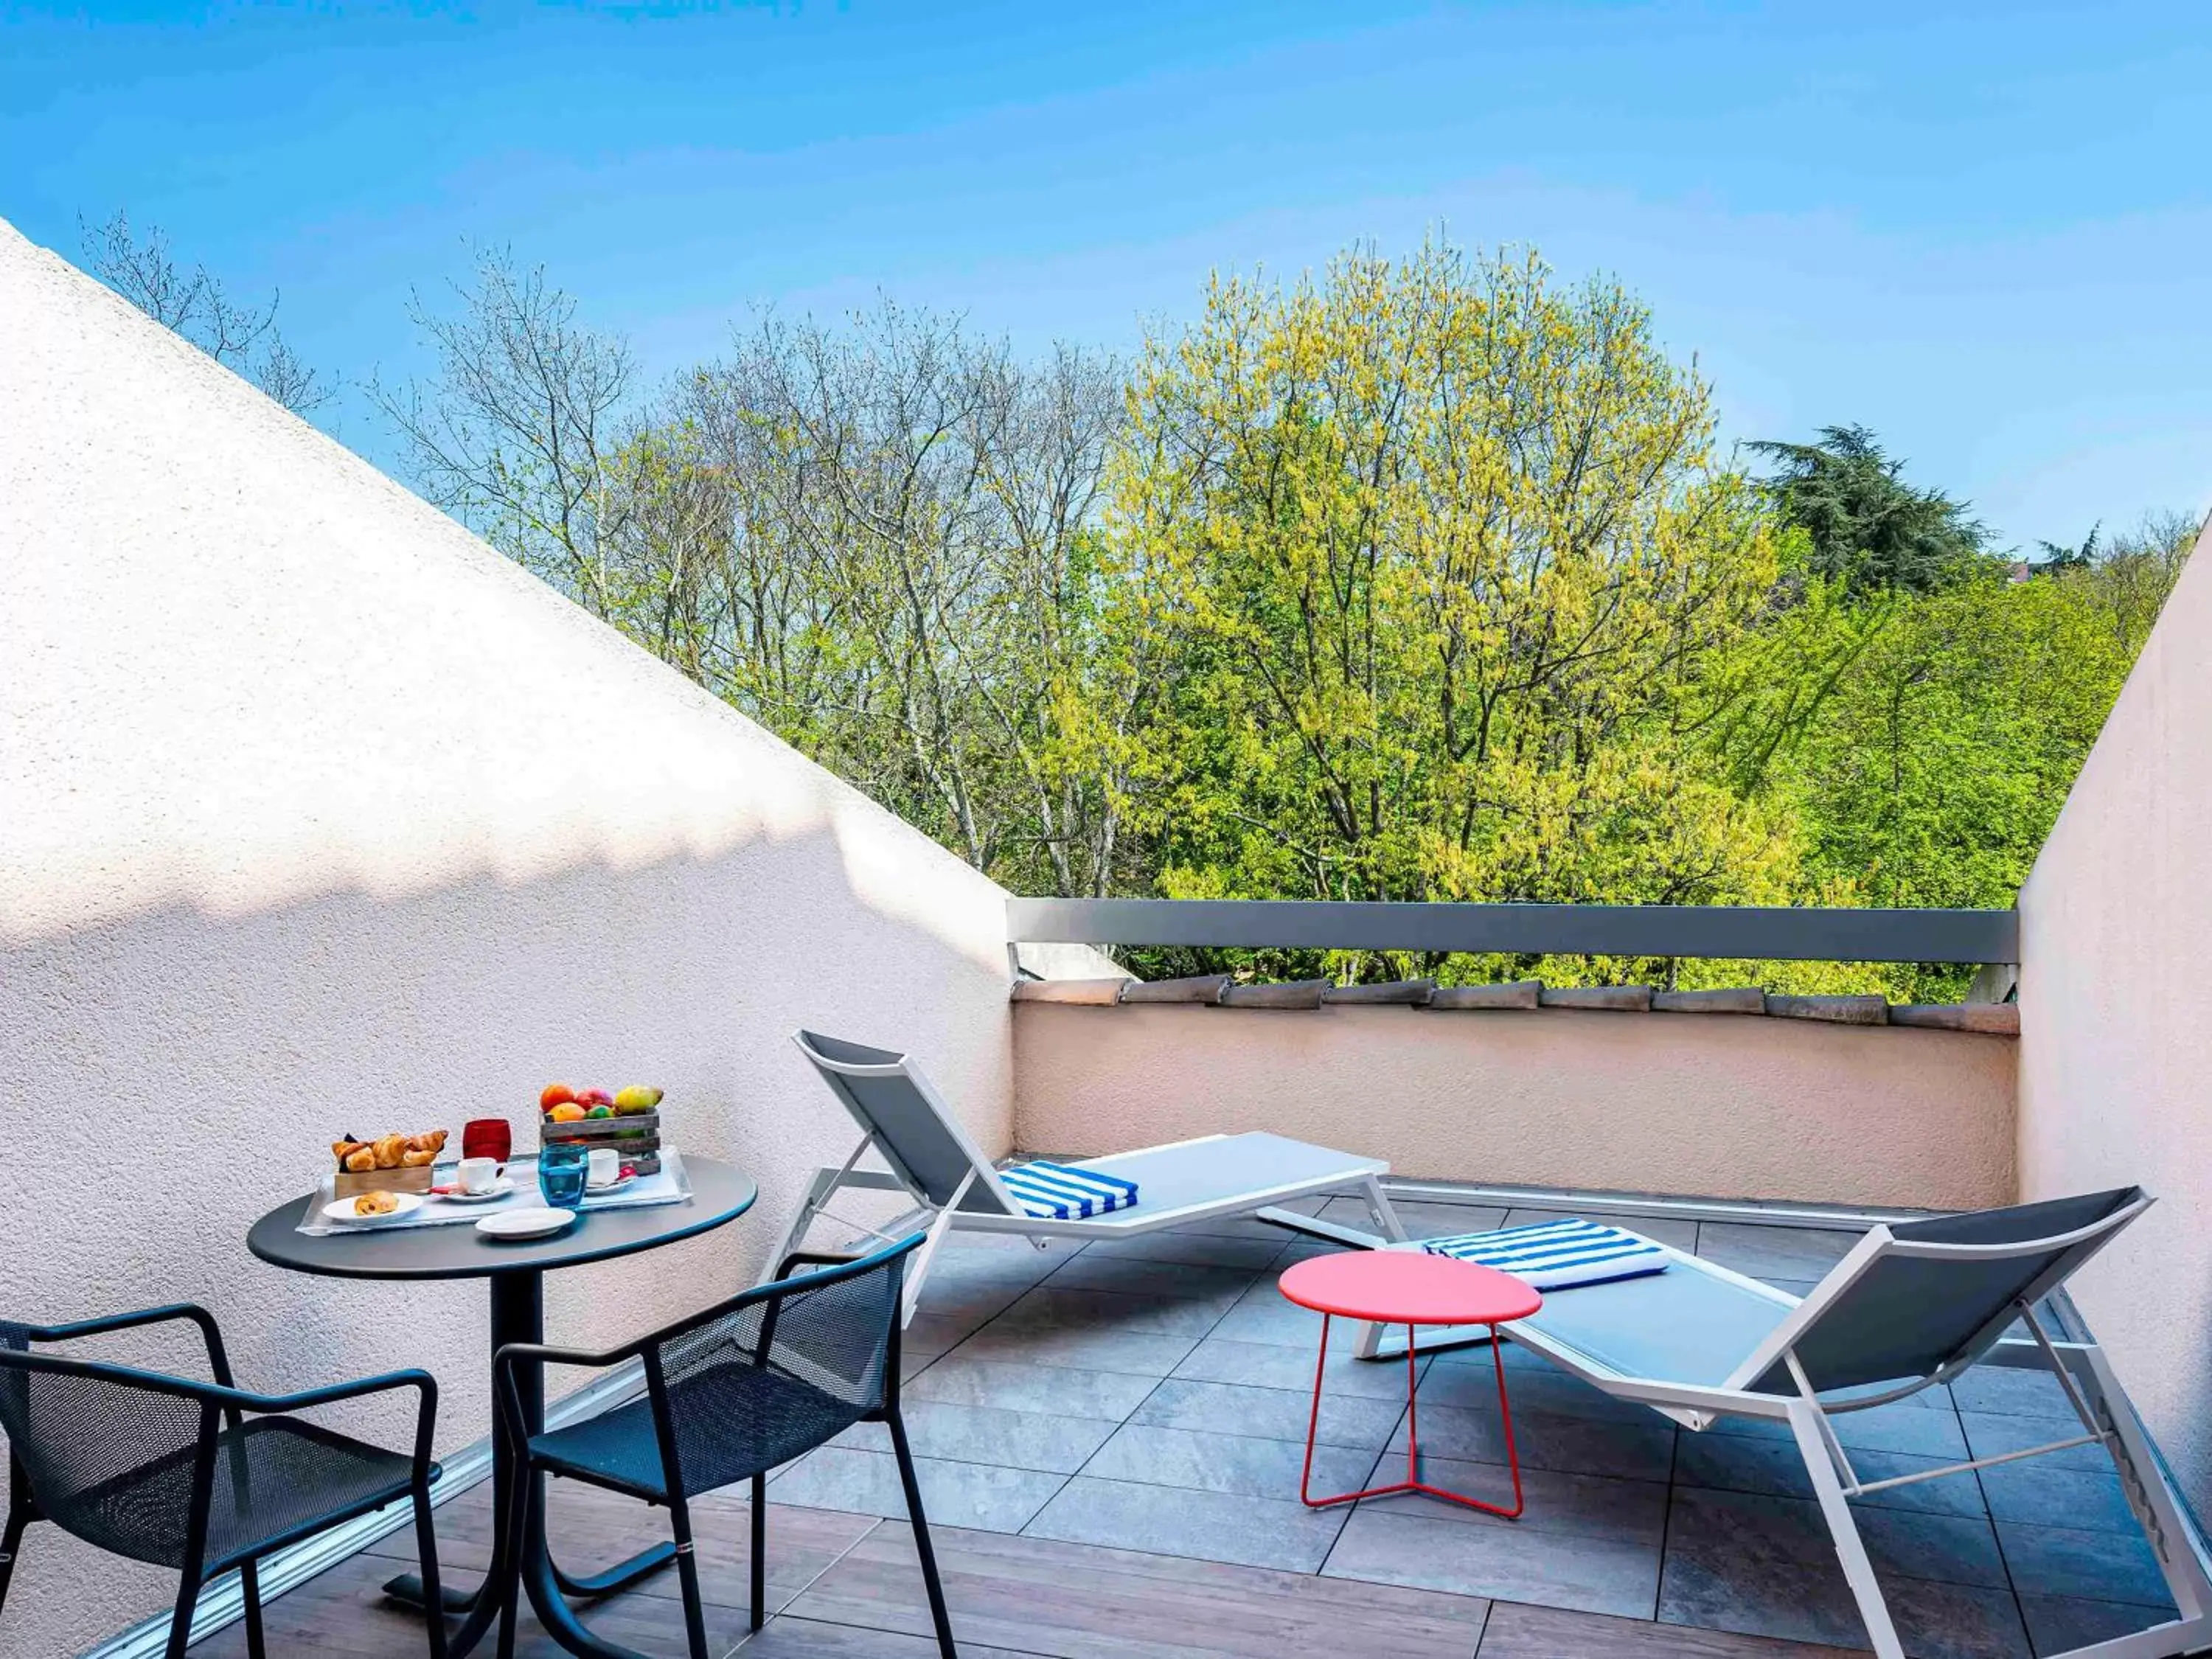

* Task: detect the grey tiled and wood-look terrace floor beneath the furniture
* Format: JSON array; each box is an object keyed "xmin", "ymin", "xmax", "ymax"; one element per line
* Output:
[{"xmin": 173, "ymin": 1188, "xmax": 2174, "ymax": 1659}]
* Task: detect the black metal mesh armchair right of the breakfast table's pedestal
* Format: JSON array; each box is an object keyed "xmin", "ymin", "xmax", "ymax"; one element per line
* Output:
[{"xmin": 493, "ymin": 1234, "xmax": 956, "ymax": 1659}]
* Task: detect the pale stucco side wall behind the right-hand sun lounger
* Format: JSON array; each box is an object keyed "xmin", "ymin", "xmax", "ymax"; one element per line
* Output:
[{"xmin": 2020, "ymin": 518, "xmax": 2212, "ymax": 1515}]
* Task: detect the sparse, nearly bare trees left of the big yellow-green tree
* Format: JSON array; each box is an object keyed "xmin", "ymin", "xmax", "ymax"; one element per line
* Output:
[{"xmin": 372, "ymin": 252, "xmax": 1155, "ymax": 894}]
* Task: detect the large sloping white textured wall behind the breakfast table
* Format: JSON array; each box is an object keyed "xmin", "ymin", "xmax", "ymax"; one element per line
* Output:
[{"xmin": 0, "ymin": 223, "xmax": 1011, "ymax": 1659}]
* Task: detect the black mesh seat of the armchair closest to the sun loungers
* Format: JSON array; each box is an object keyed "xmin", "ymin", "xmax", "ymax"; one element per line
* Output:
[{"xmin": 531, "ymin": 1360, "xmax": 863, "ymax": 1502}]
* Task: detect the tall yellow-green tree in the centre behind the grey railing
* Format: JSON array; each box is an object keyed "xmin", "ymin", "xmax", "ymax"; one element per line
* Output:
[{"xmin": 1108, "ymin": 243, "xmax": 1792, "ymax": 982}]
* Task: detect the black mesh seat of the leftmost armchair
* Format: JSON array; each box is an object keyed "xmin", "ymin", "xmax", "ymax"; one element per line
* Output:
[{"xmin": 69, "ymin": 1418, "xmax": 418, "ymax": 1568}]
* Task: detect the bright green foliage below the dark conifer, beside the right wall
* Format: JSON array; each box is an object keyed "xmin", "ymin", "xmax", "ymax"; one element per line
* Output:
[{"xmin": 1705, "ymin": 515, "xmax": 2194, "ymax": 998}]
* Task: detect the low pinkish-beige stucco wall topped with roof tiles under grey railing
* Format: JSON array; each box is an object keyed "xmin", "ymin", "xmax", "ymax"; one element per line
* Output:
[{"xmin": 1013, "ymin": 1002, "xmax": 2013, "ymax": 1208}]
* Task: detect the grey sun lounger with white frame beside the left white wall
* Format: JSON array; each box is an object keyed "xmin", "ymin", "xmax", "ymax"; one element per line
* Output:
[{"xmin": 776, "ymin": 1031, "xmax": 1405, "ymax": 1318}]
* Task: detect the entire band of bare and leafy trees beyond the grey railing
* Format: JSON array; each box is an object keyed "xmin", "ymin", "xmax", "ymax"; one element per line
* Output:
[{"xmin": 380, "ymin": 229, "xmax": 2197, "ymax": 998}]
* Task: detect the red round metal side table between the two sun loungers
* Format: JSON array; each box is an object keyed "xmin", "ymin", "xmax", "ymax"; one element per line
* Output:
[{"xmin": 1279, "ymin": 1250, "xmax": 1544, "ymax": 1520}]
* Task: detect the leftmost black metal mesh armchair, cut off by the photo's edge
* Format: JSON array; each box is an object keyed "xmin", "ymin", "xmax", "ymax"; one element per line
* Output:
[{"xmin": 0, "ymin": 1305, "xmax": 445, "ymax": 1659}]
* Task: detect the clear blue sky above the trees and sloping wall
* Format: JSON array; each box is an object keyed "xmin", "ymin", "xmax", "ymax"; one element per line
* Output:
[{"xmin": 0, "ymin": 0, "xmax": 2212, "ymax": 544}]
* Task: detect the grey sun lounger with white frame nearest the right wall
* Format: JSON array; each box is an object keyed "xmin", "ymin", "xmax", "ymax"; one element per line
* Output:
[{"xmin": 1506, "ymin": 1188, "xmax": 2212, "ymax": 1659}]
